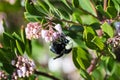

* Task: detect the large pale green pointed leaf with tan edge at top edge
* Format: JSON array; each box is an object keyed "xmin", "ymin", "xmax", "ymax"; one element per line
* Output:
[{"xmin": 79, "ymin": 0, "xmax": 97, "ymax": 16}]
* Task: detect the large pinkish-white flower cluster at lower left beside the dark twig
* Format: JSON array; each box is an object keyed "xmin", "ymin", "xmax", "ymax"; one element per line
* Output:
[{"xmin": 11, "ymin": 56, "xmax": 35, "ymax": 80}]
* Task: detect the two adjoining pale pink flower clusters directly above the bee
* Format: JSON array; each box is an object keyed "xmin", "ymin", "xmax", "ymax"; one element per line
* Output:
[{"xmin": 25, "ymin": 22, "xmax": 62, "ymax": 42}]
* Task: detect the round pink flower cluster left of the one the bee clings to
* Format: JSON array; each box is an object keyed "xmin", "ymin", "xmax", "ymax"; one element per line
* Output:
[{"xmin": 25, "ymin": 22, "xmax": 42, "ymax": 40}]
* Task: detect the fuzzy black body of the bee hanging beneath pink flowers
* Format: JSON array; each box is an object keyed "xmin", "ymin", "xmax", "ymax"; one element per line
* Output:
[{"xmin": 50, "ymin": 36, "xmax": 72, "ymax": 59}]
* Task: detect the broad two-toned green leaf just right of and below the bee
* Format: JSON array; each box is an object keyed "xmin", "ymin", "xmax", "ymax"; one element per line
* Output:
[{"xmin": 73, "ymin": 47, "xmax": 90, "ymax": 70}]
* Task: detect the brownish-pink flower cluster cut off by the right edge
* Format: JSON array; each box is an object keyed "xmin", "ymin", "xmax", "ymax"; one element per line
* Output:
[{"xmin": 107, "ymin": 35, "xmax": 120, "ymax": 47}]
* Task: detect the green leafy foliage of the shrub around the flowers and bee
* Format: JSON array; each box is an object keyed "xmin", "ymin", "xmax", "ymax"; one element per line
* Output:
[{"xmin": 0, "ymin": 0, "xmax": 120, "ymax": 80}]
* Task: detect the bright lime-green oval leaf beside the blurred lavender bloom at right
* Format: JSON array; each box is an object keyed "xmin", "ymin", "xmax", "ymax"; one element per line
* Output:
[{"xmin": 101, "ymin": 22, "xmax": 114, "ymax": 38}]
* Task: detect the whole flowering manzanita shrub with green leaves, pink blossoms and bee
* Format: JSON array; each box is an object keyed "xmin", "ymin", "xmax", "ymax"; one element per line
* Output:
[{"xmin": 0, "ymin": 0, "xmax": 120, "ymax": 80}]
